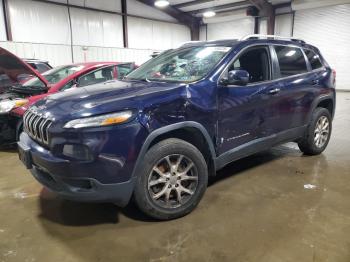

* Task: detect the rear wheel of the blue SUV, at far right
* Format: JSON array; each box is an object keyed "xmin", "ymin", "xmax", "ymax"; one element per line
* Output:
[{"xmin": 298, "ymin": 108, "xmax": 332, "ymax": 155}]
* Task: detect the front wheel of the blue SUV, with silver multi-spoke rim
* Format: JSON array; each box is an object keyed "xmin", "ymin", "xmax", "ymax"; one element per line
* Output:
[{"xmin": 134, "ymin": 138, "xmax": 208, "ymax": 220}]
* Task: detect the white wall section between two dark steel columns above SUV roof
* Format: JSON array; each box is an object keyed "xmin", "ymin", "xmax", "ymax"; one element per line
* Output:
[{"xmin": 207, "ymin": 18, "xmax": 254, "ymax": 40}]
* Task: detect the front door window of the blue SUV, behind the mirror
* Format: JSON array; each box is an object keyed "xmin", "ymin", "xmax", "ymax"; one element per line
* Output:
[{"xmin": 229, "ymin": 47, "xmax": 270, "ymax": 83}]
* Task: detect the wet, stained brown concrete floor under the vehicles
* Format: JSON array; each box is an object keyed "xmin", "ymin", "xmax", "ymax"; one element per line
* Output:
[{"xmin": 0, "ymin": 93, "xmax": 350, "ymax": 262}]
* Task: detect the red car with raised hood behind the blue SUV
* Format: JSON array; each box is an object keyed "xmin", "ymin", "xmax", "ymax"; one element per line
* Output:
[{"xmin": 0, "ymin": 48, "xmax": 136, "ymax": 145}]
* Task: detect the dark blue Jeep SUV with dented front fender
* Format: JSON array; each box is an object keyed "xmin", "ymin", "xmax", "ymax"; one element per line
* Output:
[{"xmin": 18, "ymin": 36, "xmax": 335, "ymax": 219}]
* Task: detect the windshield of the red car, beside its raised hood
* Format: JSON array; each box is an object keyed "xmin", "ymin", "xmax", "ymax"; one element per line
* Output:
[{"xmin": 22, "ymin": 65, "xmax": 84, "ymax": 87}]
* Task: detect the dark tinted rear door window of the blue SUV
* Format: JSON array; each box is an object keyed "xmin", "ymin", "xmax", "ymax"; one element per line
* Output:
[{"xmin": 275, "ymin": 46, "xmax": 308, "ymax": 77}]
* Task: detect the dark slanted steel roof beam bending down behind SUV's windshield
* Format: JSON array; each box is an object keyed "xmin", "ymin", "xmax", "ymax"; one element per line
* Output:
[{"xmin": 137, "ymin": 0, "xmax": 201, "ymax": 41}]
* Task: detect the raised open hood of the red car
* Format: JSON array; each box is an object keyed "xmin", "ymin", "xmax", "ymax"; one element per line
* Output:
[{"xmin": 0, "ymin": 47, "xmax": 48, "ymax": 93}]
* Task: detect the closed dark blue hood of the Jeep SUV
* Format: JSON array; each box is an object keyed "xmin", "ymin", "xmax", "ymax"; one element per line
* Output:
[{"xmin": 35, "ymin": 80, "xmax": 186, "ymax": 119}]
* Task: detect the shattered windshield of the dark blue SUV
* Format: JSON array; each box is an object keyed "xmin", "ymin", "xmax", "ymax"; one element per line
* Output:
[{"xmin": 126, "ymin": 46, "xmax": 231, "ymax": 82}]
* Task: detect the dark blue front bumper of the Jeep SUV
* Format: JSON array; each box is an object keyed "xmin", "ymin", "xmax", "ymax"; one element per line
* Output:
[{"xmin": 18, "ymin": 121, "xmax": 144, "ymax": 206}]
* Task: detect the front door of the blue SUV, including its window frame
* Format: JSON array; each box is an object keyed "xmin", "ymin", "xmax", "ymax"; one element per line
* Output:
[{"xmin": 218, "ymin": 46, "xmax": 278, "ymax": 155}]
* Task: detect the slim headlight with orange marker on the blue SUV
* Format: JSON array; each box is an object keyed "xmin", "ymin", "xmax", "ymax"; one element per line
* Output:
[{"xmin": 64, "ymin": 111, "xmax": 132, "ymax": 128}]
